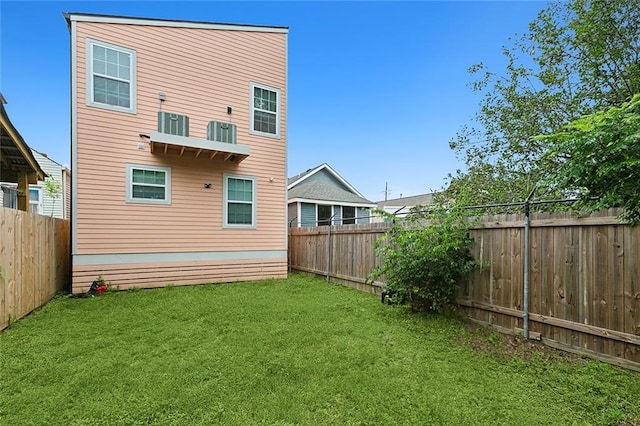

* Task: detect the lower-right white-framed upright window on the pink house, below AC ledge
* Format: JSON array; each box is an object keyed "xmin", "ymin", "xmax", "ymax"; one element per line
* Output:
[{"xmin": 224, "ymin": 174, "xmax": 256, "ymax": 228}]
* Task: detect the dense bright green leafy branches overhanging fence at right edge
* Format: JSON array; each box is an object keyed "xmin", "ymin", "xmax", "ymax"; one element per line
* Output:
[{"xmin": 537, "ymin": 94, "xmax": 640, "ymax": 225}]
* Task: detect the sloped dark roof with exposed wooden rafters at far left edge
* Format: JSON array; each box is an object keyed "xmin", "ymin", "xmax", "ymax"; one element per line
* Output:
[{"xmin": 0, "ymin": 99, "xmax": 47, "ymax": 183}]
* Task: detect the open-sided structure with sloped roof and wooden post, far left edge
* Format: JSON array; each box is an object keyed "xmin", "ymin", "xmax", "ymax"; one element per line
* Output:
[{"xmin": 0, "ymin": 94, "xmax": 46, "ymax": 211}]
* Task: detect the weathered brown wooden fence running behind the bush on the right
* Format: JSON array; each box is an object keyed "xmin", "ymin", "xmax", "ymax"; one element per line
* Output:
[{"xmin": 289, "ymin": 211, "xmax": 640, "ymax": 369}]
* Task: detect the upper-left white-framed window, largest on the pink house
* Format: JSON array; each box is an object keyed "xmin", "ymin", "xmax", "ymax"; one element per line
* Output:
[{"xmin": 87, "ymin": 39, "xmax": 136, "ymax": 113}]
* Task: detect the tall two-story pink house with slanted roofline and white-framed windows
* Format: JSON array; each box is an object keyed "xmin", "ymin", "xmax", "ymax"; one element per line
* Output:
[{"xmin": 65, "ymin": 13, "xmax": 288, "ymax": 293}]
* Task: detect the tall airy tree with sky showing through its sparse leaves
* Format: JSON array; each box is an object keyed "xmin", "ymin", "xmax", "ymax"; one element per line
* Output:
[{"xmin": 447, "ymin": 0, "xmax": 640, "ymax": 204}]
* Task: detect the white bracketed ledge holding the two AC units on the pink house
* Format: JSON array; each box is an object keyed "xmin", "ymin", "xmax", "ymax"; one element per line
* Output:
[{"xmin": 150, "ymin": 132, "xmax": 251, "ymax": 163}]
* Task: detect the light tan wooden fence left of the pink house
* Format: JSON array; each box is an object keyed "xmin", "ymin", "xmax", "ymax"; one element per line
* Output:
[{"xmin": 0, "ymin": 207, "xmax": 71, "ymax": 330}]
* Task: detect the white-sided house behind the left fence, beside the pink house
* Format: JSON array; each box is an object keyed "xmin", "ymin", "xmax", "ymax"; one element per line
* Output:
[{"xmin": 0, "ymin": 149, "xmax": 71, "ymax": 219}]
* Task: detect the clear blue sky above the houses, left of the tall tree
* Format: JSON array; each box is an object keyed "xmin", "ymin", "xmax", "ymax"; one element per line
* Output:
[{"xmin": 0, "ymin": 0, "xmax": 546, "ymax": 201}]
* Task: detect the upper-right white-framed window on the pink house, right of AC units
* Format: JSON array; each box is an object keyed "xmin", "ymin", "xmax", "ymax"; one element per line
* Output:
[{"xmin": 250, "ymin": 83, "xmax": 280, "ymax": 137}]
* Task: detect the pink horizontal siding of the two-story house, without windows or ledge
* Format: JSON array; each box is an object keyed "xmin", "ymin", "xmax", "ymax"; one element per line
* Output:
[{"xmin": 73, "ymin": 22, "xmax": 287, "ymax": 289}]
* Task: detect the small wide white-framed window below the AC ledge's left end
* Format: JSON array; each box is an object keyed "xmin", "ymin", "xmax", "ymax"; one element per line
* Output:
[{"xmin": 126, "ymin": 164, "xmax": 171, "ymax": 204}]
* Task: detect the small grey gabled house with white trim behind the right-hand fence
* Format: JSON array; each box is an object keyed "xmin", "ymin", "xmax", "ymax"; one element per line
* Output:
[{"xmin": 288, "ymin": 163, "xmax": 376, "ymax": 227}]
